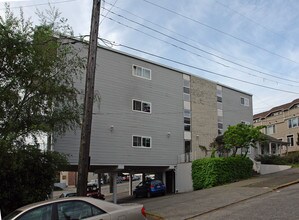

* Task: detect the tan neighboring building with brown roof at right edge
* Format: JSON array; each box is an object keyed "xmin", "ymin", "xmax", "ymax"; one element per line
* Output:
[{"xmin": 253, "ymin": 99, "xmax": 299, "ymax": 154}]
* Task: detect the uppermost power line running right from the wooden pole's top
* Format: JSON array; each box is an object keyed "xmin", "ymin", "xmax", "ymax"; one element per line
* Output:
[{"xmin": 104, "ymin": 2, "xmax": 299, "ymax": 85}]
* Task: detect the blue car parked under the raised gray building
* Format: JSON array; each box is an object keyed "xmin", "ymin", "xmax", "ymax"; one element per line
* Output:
[{"xmin": 133, "ymin": 179, "xmax": 166, "ymax": 198}]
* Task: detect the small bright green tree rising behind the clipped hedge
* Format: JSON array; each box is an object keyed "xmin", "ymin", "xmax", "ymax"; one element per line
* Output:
[{"xmin": 223, "ymin": 123, "xmax": 263, "ymax": 157}]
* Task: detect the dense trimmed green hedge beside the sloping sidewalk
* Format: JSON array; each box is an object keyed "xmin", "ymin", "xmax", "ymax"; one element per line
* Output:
[{"xmin": 192, "ymin": 156, "xmax": 253, "ymax": 190}]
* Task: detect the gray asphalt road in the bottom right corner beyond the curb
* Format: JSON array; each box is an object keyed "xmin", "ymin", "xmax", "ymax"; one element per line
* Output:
[{"xmin": 193, "ymin": 184, "xmax": 299, "ymax": 220}]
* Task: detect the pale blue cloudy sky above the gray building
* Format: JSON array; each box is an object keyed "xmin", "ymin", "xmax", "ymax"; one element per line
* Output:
[{"xmin": 0, "ymin": 0, "xmax": 299, "ymax": 113}]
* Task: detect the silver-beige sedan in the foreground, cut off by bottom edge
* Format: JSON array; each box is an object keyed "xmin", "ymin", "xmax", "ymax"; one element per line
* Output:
[{"xmin": 3, "ymin": 197, "xmax": 146, "ymax": 220}]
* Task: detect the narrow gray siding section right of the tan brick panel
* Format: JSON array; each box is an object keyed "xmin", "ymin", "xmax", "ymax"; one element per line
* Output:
[{"xmin": 222, "ymin": 86, "xmax": 253, "ymax": 131}]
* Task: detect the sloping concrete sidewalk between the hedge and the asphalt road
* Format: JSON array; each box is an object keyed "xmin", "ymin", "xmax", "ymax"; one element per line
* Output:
[{"xmin": 144, "ymin": 168, "xmax": 299, "ymax": 219}]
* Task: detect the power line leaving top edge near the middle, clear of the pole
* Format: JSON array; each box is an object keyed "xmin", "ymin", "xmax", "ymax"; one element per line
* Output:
[{"xmin": 143, "ymin": 0, "xmax": 299, "ymax": 64}]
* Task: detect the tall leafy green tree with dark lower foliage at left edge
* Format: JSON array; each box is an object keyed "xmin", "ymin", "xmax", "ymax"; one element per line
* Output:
[{"xmin": 0, "ymin": 5, "xmax": 86, "ymax": 215}]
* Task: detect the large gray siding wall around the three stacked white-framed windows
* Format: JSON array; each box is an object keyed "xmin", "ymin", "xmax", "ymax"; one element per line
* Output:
[{"xmin": 54, "ymin": 46, "xmax": 184, "ymax": 166}]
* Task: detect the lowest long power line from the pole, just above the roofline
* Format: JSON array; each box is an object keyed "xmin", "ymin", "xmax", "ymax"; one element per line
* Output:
[{"xmin": 100, "ymin": 38, "xmax": 299, "ymax": 95}]
